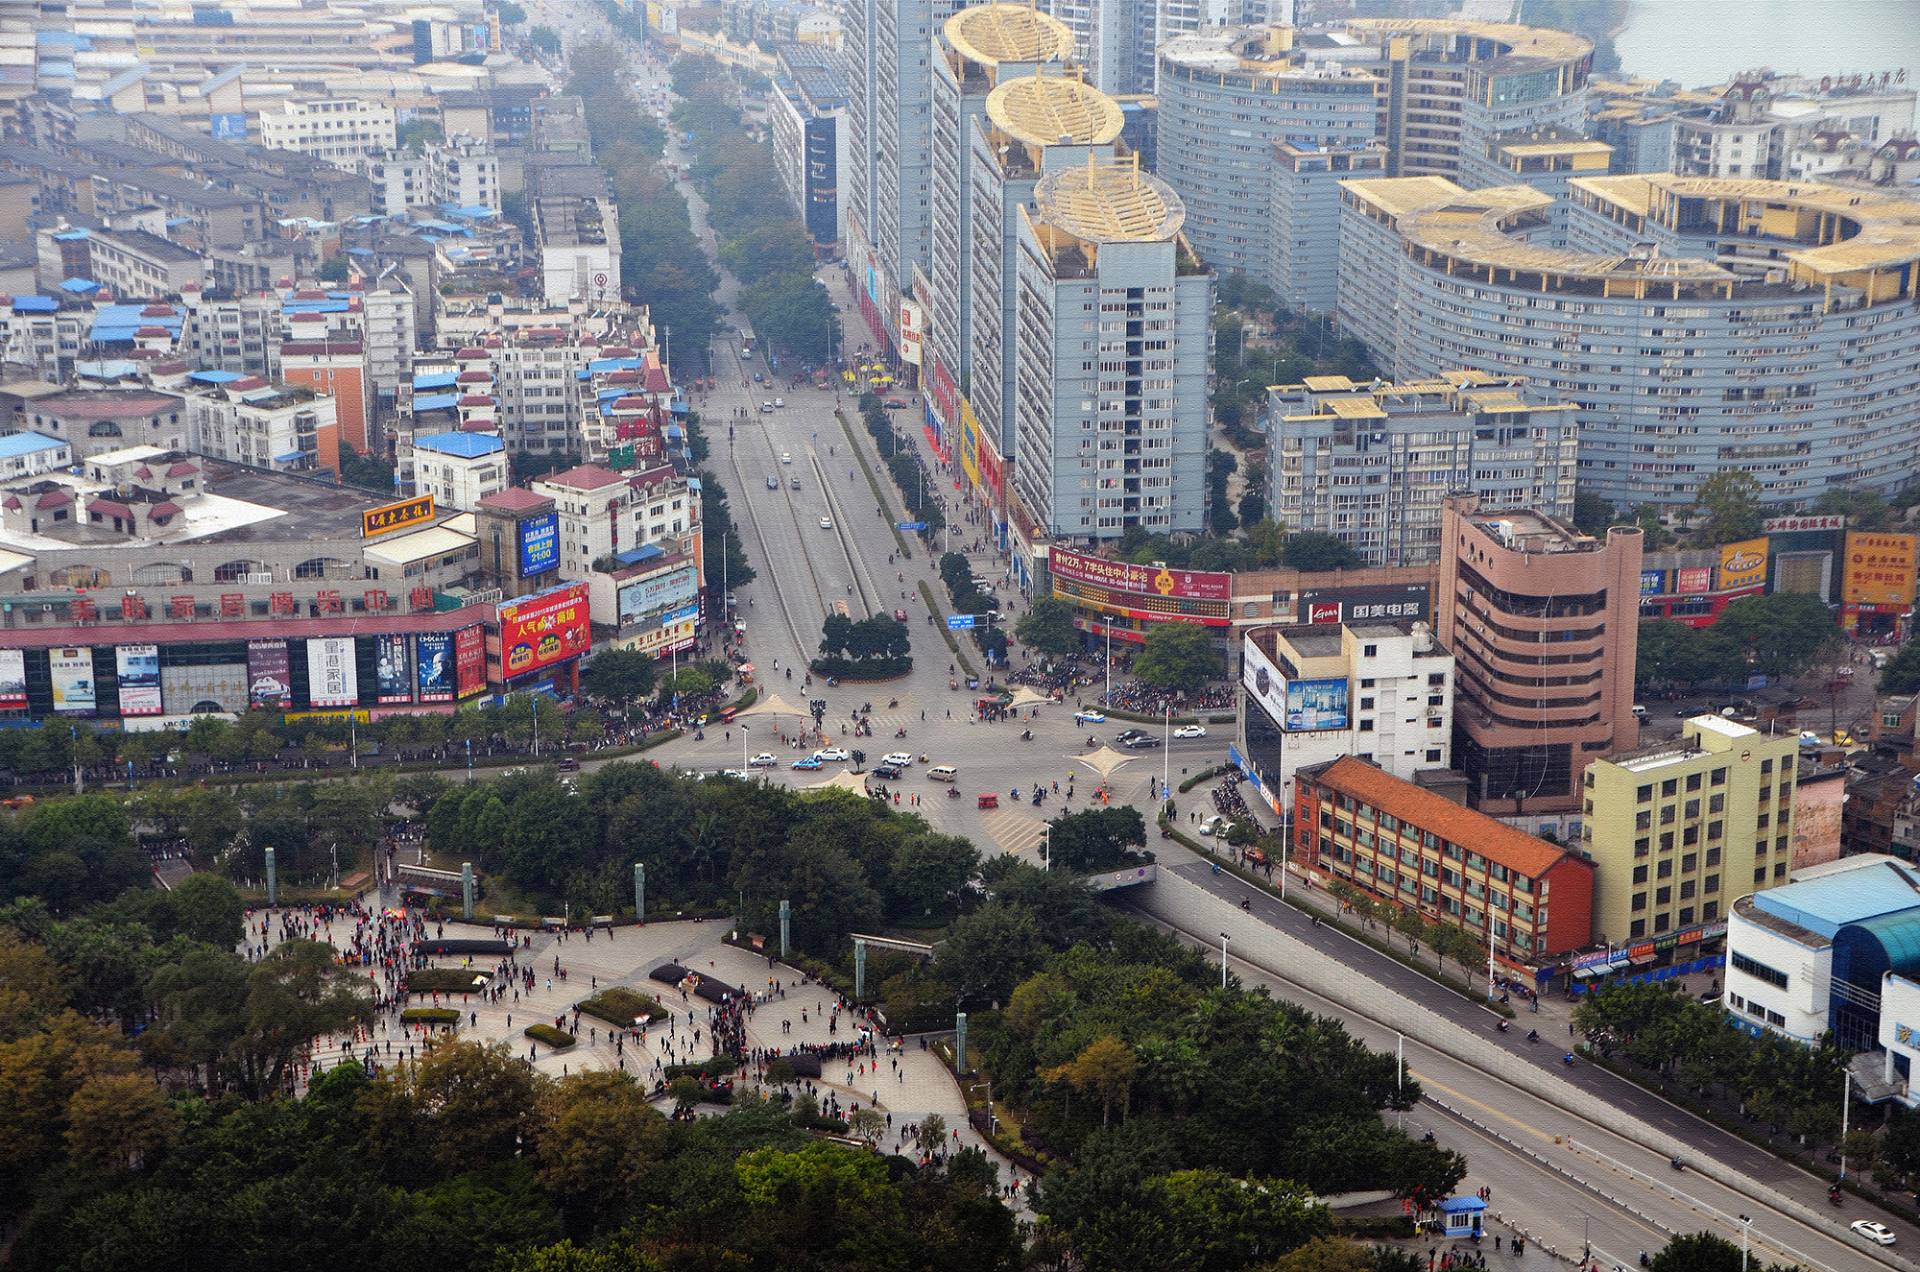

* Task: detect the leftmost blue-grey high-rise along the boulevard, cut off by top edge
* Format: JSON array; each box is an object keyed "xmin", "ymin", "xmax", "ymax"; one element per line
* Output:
[{"xmin": 845, "ymin": 0, "xmax": 966, "ymax": 348}]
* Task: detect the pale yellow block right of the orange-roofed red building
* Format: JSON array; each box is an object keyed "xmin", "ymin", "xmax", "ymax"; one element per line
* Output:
[{"xmin": 1580, "ymin": 715, "xmax": 1799, "ymax": 943}]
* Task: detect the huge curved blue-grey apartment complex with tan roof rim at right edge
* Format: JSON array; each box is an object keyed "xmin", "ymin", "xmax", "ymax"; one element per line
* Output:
[{"xmin": 1338, "ymin": 175, "xmax": 1920, "ymax": 507}]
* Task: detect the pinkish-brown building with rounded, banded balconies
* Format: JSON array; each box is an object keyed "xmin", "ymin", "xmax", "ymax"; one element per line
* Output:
[{"xmin": 1438, "ymin": 496, "xmax": 1642, "ymax": 815}]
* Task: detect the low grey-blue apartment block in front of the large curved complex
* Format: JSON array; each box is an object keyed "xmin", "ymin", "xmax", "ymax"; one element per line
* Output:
[{"xmin": 1265, "ymin": 371, "xmax": 1580, "ymax": 565}]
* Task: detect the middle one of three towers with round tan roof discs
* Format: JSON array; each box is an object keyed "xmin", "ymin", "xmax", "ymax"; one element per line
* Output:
[{"xmin": 975, "ymin": 75, "xmax": 1125, "ymax": 484}]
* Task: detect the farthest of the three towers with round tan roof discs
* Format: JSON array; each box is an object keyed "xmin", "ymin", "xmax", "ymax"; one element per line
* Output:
[{"xmin": 922, "ymin": 4, "xmax": 1073, "ymax": 422}]
